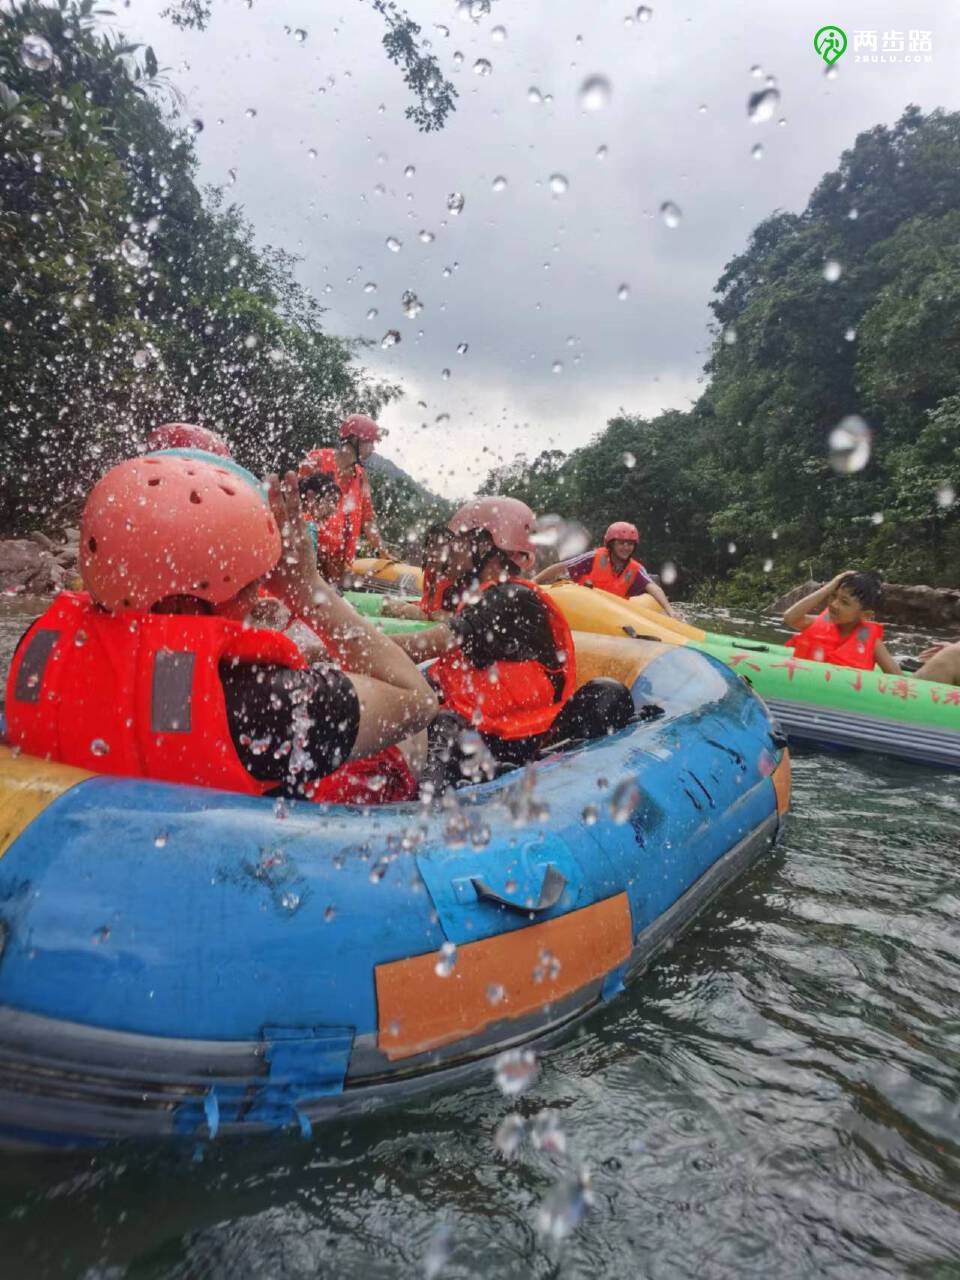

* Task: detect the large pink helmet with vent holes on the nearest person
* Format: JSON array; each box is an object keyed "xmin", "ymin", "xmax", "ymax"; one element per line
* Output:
[{"xmin": 79, "ymin": 453, "xmax": 280, "ymax": 609}]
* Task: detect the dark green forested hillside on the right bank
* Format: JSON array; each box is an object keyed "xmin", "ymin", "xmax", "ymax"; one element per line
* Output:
[{"xmin": 484, "ymin": 108, "xmax": 960, "ymax": 603}]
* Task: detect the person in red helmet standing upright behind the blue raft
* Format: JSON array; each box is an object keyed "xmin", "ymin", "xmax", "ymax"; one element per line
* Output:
[{"xmin": 300, "ymin": 413, "xmax": 390, "ymax": 581}]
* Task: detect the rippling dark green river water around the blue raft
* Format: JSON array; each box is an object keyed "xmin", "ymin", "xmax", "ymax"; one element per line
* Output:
[{"xmin": 0, "ymin": 611, "xmax": 960, "ymax": 1280}]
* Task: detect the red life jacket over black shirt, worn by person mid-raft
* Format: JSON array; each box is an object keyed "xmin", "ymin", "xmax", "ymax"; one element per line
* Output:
[{"xmin": 430, "ymin": 577, "xmax": 576, "ymax": 740}]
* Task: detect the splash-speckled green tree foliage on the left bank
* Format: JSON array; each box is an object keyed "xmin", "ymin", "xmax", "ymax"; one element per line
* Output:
[{"xmin": 0, "ymin": 0, "xmax": 412, "ymax": 530}]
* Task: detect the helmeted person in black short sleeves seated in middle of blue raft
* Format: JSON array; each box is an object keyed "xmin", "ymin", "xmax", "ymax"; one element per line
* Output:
[{"xmin": 396, "ymin": 498, "xmax": 576, "ymax": 778}]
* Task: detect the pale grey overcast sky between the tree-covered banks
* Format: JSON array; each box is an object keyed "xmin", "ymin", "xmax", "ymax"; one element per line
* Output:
[{"xmin": 124, "ymin": 0, "xmax": 960, "ymax": 495}]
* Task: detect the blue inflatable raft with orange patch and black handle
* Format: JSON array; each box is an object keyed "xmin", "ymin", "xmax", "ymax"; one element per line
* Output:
[{"xmin": 0, "ymin": 635, "xmax": 790, "ymax": 1147}]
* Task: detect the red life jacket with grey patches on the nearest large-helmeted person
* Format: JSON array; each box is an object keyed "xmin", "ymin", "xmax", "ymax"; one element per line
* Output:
[{"xmin": 6, "ymin": 591, "xmax": 306, "ymax": 795}]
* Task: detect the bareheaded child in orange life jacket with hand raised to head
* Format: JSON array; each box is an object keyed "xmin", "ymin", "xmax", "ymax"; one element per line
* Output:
[{"xmin": 783, "ymin": 570, "xmax": 900, "ymax": 676}]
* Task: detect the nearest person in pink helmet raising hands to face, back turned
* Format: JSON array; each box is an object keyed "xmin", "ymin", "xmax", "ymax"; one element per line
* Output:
[{"xmin": 6, "ymin": 453, "xmax": 436, "ymax": 800}]
